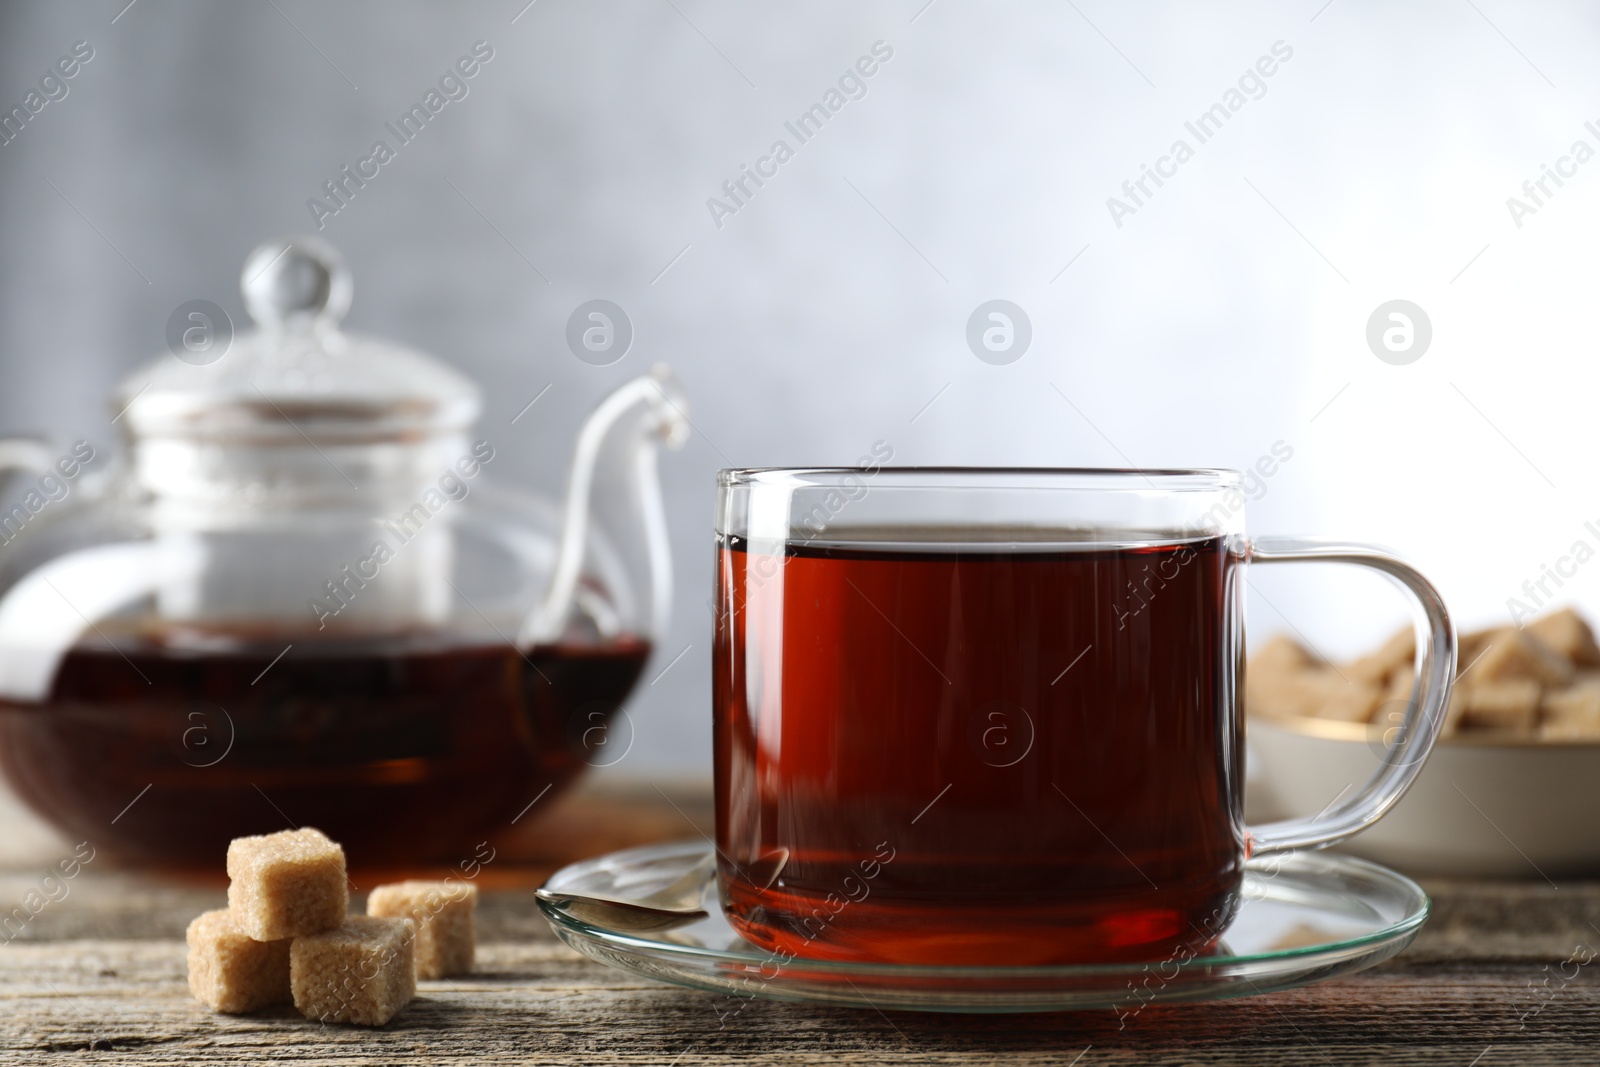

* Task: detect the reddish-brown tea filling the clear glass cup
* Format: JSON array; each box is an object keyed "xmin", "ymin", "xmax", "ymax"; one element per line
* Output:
[{"xmin": 714, "ymin": 531, "xmax": 1243, "ymax": 965}]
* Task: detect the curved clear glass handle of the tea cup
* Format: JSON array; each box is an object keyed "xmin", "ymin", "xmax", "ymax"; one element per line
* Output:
[{"xmin": 1246, "ymin": 537, "xmax": 1456, "ymax": 856}]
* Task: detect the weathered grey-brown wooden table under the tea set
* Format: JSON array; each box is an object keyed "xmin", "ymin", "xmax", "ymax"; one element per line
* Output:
[{"xmin": 0, "ymin": 782, "xmax": 1600, "ymax": 1067}]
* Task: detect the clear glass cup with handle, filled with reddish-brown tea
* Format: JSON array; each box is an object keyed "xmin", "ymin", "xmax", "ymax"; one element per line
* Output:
[{"xmin": 712, "ymin": 467, "xmax": 1456, "ymax": 965}]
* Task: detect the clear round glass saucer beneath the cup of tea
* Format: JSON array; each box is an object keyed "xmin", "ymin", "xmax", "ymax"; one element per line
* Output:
[{"xmin": 539, "ymin": 841, "xmax": 1430, "ymax": 1013}]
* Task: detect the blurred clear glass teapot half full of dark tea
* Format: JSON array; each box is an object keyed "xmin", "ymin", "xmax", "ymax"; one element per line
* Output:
[{"xmin": 0, "ymin": 237, "xmax": 688, "ymax": 869}]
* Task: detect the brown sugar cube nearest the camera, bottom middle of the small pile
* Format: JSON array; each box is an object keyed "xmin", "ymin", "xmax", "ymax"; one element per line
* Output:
[{"xmin": 290, "ymin": 915, "xmax": 416, "ymax": 1027}]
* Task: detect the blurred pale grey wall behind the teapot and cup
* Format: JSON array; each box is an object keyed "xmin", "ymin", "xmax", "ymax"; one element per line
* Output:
[{"xmin": 0, "ymin": 0, "xmax": 1600, "ymax": 776}]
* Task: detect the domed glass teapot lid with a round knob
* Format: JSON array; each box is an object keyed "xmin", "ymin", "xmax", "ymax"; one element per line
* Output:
[{"xmin": 114, "ymin": 237, "xmax": 482, "ymax": 445}]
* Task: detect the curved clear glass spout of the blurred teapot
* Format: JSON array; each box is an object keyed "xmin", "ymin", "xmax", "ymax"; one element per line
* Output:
[{"xmin": 518, "ymin": 363, "xmax": 690, "ymax": 646}]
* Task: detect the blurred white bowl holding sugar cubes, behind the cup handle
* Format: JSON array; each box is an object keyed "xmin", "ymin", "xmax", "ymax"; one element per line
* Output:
[{"xmin": 1246, "ymin": 715, "xmax": 1600, "ymax": 880}]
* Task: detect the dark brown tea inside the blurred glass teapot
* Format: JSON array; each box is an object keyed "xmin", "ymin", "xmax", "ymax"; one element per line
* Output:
[{"xmin": 0, "ymin": 635, "xmax": 650, "ymax": 869}]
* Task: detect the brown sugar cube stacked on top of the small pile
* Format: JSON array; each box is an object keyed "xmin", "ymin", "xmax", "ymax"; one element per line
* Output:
[{"xmin": 227, "ymin": 827, "xmax": 350, "ymax": 941}]
